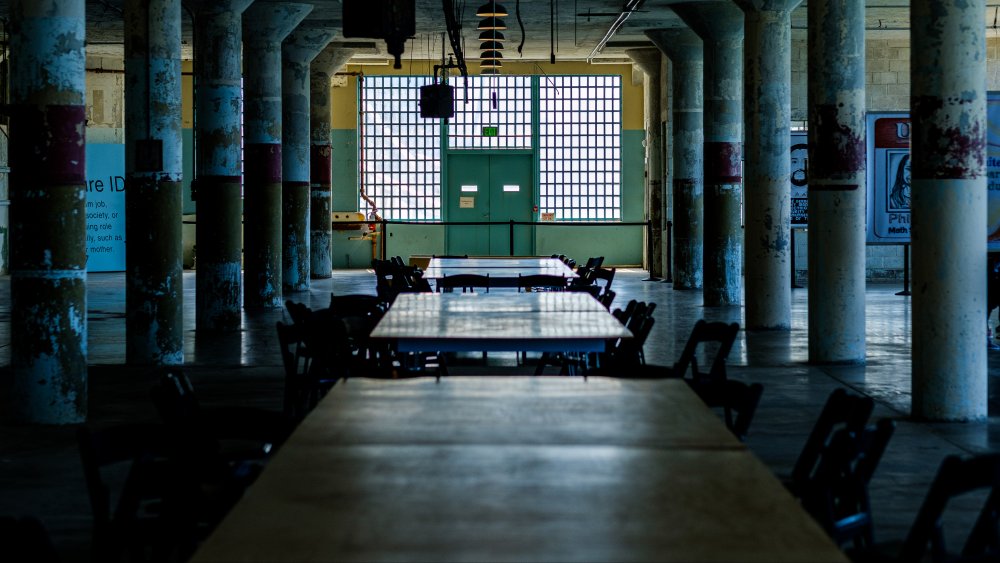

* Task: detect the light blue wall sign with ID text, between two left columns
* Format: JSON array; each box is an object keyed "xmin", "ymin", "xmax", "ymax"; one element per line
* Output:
[{"xmin": 86, "ymin": 144, "xmax": 125, "ymax": 272}]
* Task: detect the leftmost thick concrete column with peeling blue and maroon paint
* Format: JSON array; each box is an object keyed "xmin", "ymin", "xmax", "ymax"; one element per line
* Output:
[{"xmin": 9, "ymin": 0, "xmax": 87, "ymax": 424}]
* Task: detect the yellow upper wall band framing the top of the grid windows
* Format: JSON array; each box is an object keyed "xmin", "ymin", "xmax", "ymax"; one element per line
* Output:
[{"xmin": 330, "ymin": 61, "xmax": 643, "ymax": 129}]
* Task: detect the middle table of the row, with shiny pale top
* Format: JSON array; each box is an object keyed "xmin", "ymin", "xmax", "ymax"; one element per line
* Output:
[{"xmin": 371, "ymin": 291, "xmax": 632, "ymax": 352}]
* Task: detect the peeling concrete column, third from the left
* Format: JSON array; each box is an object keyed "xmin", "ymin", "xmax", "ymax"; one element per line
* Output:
[{"xmin": 193, "ymin": 0, "xmax": 253, "ymax": 331}]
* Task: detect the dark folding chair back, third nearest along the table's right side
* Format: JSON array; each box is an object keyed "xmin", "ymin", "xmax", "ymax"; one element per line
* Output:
[{"xmin": 790, "ymin": 388, "xmax": 875, "ymax": 494}]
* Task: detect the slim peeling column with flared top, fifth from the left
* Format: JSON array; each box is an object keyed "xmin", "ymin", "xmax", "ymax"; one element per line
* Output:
[{"xmin": 281, "ymin": 20, "xmax": 338, "ymax": 292}]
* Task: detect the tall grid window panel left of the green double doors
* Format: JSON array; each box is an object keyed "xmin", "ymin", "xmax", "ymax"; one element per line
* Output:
[{"xmin": 358, "ymin": 76, "xmax": 441, "ymax": 221}]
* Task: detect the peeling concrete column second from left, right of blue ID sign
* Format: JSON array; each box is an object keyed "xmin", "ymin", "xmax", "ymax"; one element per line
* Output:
[{"xmin": 125, "ymin": 0, "xmax": 184, "ymax": 365}]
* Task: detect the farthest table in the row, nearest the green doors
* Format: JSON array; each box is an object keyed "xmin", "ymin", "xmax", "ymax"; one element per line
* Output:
[{"xmin": 424, "ymin": 257, "xmax": 579, "ymax": 288}]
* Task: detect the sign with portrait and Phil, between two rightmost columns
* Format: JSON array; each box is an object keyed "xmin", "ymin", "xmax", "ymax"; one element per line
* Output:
[{"xmin": 866, "ymin": 112, "xmax": 910, "ymax": 244}]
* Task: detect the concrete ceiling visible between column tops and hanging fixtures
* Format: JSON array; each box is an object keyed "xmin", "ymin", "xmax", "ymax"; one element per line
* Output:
[{"xmin": 11, "ymin": 0, "xmax": 1000, "ymax": 62}]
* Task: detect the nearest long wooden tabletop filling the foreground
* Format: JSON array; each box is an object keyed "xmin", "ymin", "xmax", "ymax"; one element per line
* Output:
[{"xmin": 192, "ymin": 377, "xmax": 847, "ymax": 562}]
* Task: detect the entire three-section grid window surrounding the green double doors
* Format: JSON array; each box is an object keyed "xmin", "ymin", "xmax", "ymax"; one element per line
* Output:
[{"xmin": 358, "ymin": 75, "xmax": 623, "ymax": 222}]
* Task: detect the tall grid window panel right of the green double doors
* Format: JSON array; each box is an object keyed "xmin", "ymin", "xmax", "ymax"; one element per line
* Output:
[{"xmin": 539, "ymin": 76, "xmax": 622, "ymax": 221}]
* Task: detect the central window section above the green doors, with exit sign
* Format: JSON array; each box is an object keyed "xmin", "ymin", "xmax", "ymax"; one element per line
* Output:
[{"xmin": 448, "ymin": 75, "xmax": 531, "ymax": 149}]
